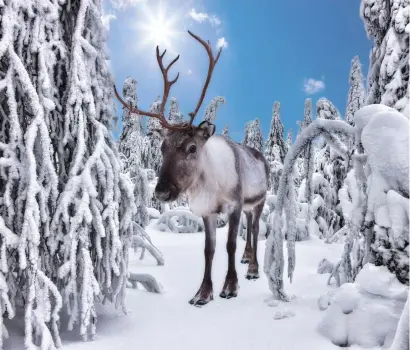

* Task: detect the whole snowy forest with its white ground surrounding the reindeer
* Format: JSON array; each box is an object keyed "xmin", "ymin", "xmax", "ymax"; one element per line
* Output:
[{"xmin": 0, "ymin": 0, "xmax": 410, "ymax": 350}]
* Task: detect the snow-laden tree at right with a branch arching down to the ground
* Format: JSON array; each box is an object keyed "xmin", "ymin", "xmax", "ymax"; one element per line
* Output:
[{"xmin": 264, "ymin": 105, "xmax": 409, "ymax": 300}]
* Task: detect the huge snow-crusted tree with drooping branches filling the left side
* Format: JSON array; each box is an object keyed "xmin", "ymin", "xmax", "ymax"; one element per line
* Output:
[{"xmin": 0, "ymin": 0, "xmax": 134, "ymax": 344}]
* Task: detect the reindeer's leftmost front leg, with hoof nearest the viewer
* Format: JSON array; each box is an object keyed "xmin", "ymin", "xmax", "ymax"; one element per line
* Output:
[{"xmin": 189, "ymin": 214, "xmax": 218, "ymax": 306}]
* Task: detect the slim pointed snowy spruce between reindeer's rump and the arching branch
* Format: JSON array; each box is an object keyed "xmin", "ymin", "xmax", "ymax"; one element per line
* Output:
[{"xmin": 264, "ymin": 101, "xmax": 287, "ymax": 164}]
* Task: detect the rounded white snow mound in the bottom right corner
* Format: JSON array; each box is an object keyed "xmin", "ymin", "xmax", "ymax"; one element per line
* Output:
[{"xmin": 318, "ymin": 264, "xmax": 408, "ymax": 348}]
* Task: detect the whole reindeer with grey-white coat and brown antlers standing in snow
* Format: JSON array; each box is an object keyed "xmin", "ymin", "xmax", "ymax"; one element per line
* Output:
[{"xmin": 114, "ymin": 31, "xmax": 268, "ymax": 306}]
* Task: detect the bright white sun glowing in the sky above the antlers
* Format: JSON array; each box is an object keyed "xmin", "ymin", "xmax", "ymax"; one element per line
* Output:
[{"xmin": 137, "ymin": 2, "xmax": 180, "ymax": 50}]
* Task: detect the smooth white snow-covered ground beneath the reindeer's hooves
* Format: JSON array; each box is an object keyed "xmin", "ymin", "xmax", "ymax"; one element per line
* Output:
[{"xmin": 5, "ymin": 223, "xmax": 404, "ymax": 350}]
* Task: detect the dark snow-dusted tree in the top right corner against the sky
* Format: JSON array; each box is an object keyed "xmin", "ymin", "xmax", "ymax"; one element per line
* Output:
[{"xmin": 360, "ymin": 0, "xmax": 410, "ymax": 117}]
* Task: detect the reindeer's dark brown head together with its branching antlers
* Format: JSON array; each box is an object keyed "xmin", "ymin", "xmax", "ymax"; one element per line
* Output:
[{"xmin": 114, "ymin": 31, "xmax": 222, "ymax": 202}]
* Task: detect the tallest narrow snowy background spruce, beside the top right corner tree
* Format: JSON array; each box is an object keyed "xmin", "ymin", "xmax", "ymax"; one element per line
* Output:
[{"xmin": 345, "ymin": 56, "xmax": 365, "ymax": 125}]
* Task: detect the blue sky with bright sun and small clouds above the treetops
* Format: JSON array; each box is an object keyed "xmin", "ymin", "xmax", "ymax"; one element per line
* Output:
[{"xmin": 103, "ymin": 0, "xmax": 371, "ymax": 141}]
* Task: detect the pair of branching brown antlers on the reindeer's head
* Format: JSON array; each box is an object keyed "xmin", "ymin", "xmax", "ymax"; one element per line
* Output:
[{"xmin": 114, "ymin": 30, "xmax": 222, "ymax": 130}]
